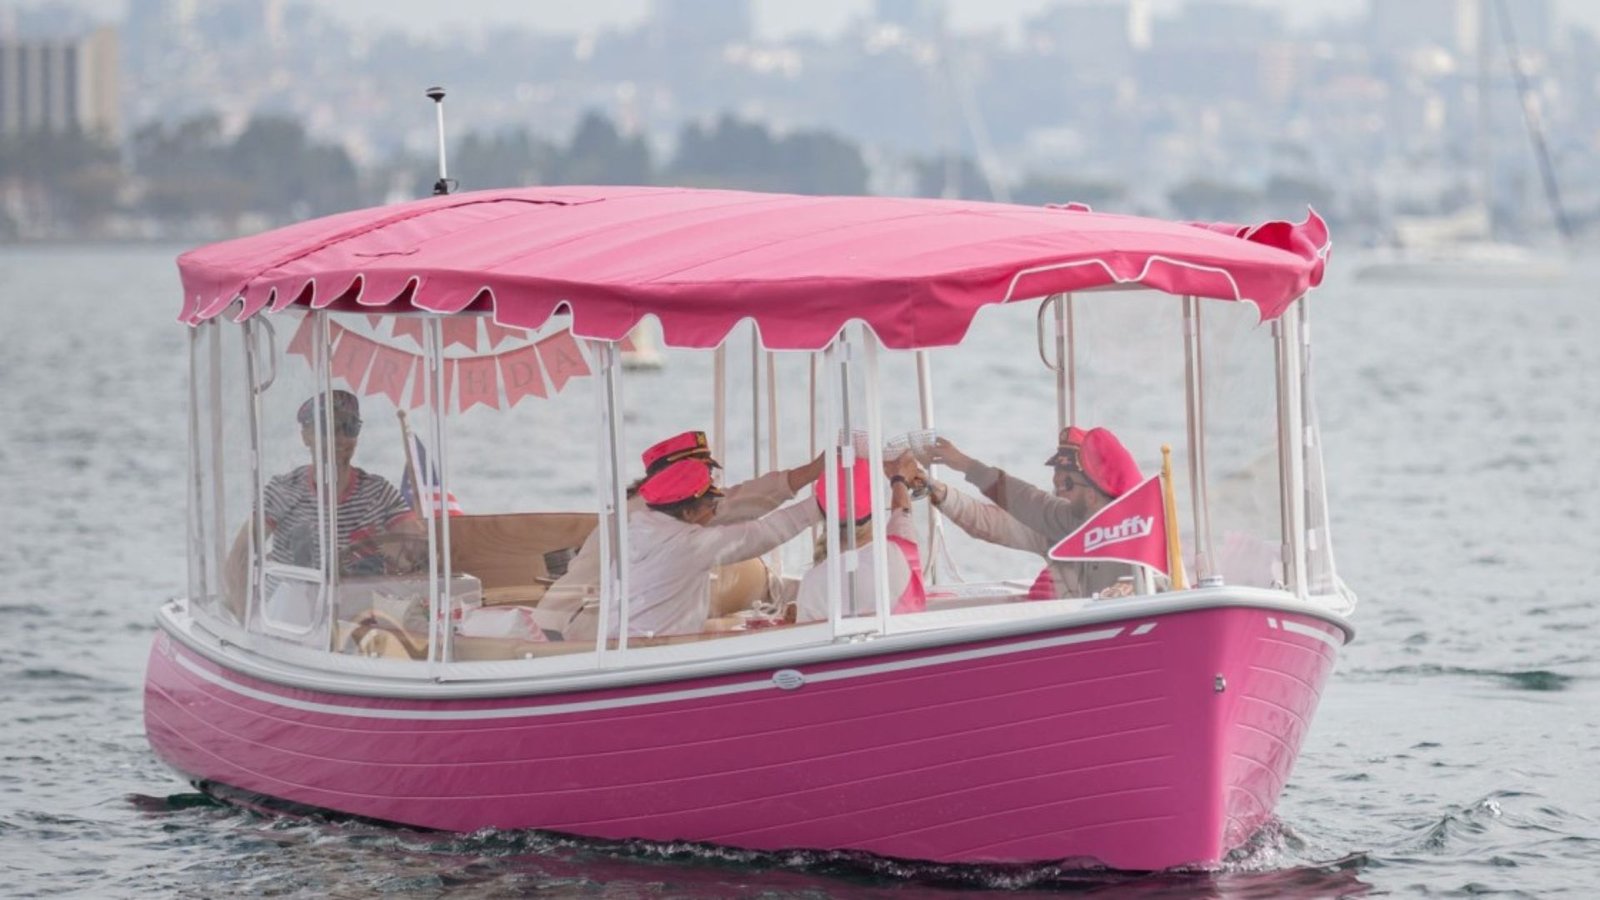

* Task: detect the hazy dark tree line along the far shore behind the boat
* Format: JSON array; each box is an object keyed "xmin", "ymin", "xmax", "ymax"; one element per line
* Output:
[{"xmin": 0, "ymin": 112, "xmax": 1330, "ymax": 239}]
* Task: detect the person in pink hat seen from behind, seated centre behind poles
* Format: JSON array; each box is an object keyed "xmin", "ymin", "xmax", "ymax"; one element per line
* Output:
[{"xmin": 795, "ymin": 460, "xmax": 928, "ymax": 621}]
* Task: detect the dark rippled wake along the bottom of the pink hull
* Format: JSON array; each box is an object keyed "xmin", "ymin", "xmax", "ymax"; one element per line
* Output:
[{"xmin": 137, "ymin": 793, "xmax": 1370, "ymax": 900}]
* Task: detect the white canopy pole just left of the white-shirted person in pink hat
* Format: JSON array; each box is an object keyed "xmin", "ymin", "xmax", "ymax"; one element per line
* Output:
[{"xmin": 587, "ymin": 341, "xmax": 630, "ymax": 650}]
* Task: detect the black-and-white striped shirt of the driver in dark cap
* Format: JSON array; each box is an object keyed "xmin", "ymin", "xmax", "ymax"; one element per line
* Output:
[{"xmin": 264, "ymin": 466, "xmax": 411, "ymax": 573}]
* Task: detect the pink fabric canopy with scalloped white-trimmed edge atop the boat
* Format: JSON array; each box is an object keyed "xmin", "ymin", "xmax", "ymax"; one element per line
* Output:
[{"xmin": 178, "ymin": 187, "xmax": 1328, "ymax": 349}]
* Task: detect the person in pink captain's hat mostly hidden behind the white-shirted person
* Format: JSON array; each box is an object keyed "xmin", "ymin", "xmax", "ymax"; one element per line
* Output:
[{"xmin": 539, "ymin": 431, "xmax": 822, "ymax": 630}]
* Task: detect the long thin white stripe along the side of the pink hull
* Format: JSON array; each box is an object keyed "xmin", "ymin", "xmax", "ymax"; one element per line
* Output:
[{"xmin": 173, "ymin": 623, "xmax": 1155, "ymax": 722}]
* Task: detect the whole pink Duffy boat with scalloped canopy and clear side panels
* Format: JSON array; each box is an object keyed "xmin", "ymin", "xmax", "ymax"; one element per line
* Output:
[{"xmin": 146, "ymin": 187, "xmax": 1355, "ymax": 870}]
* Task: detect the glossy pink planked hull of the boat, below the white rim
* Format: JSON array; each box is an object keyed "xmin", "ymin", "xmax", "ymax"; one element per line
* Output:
[{"xmin": 146, "ymin": 607, "xmax": 1344, "ymax": 870}]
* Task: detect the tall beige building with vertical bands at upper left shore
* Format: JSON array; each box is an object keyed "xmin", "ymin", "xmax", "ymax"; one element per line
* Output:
[{"xmin": 0, "ymin": 27, "xmax": 122, "ymax": 143}]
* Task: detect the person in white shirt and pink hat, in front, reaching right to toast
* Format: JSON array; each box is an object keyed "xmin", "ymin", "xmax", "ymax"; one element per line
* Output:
[{"xmin": 574, "ymin": 458, "xmax": 822, "ymax": 637}]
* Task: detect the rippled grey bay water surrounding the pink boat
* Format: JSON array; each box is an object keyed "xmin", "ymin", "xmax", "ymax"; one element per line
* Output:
[{"xmin": 0, "ymin": 247, "xmax": 1600, "ymax": 898}]
